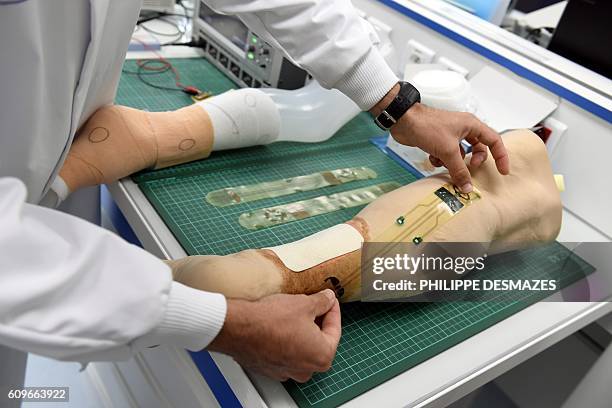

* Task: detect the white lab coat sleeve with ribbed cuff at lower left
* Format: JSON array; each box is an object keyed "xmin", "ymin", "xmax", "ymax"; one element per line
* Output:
[{"xmin": 0, "ymin": 177, "xmax": 226, "ymax": 362}]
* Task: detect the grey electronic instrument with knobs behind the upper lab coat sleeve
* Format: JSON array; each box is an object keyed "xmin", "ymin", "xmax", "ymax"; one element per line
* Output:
[{"xmin": 192, "ymin": 1, "xmax": 308, "ymax": 89}]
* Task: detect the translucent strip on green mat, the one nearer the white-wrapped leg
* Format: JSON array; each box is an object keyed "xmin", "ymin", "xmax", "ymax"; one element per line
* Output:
[{"xmin": 206, "ymin": 167, "xmax": 377, "ymax": 207}]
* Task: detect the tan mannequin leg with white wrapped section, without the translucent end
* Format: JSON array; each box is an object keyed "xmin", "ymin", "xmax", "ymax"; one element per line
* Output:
[{"xmin": 52, "ymin": 89, "xmax": 280, "ymax": 200}]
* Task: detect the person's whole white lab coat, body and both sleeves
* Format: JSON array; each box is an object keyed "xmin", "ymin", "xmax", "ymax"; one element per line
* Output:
[{"xmin": 0, "ymin": 0, "xmax": 397, "ymax": 372}]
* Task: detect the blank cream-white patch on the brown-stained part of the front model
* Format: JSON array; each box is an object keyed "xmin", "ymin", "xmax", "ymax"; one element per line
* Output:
[{"xmin": 264, "ymin": 224, "xmax": 363, "ymax": 272}]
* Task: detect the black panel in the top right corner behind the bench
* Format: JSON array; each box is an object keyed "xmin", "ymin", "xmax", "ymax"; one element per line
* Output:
[{"xmin": 548, "ymin": 0, "xmax": 612, "ymax": 79}]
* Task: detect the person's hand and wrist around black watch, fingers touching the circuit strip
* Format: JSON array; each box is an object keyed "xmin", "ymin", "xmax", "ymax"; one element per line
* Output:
[{"xmin": 371, "ymin": 85, "xmax": 510, "ymax": 193}]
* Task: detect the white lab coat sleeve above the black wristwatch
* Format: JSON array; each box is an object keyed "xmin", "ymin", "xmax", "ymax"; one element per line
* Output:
[{"xmin": 206, "ymin": 0, "xmax": 398, "ymax": 110}]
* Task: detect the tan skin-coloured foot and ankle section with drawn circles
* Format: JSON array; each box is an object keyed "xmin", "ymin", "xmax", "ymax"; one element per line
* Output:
[{"xmin": 60, "ymin": 105, "xmax": 213, "ymax": 192}]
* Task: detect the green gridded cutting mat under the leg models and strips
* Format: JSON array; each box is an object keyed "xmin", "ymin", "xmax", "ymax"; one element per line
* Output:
[{"xmin": 117, "ymin": 59, "xmax": 592, "ymax": 407}]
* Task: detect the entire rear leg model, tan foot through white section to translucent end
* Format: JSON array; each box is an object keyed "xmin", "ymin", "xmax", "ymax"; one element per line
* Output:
[{"xmin": 51, "ymin": 81, "xmax": 359, "ymax": 202}]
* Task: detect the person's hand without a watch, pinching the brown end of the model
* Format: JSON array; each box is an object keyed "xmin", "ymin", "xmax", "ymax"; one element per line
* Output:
[{"xmin": 208, "ymin": 289, "xmax": 341, "ymax": 382}]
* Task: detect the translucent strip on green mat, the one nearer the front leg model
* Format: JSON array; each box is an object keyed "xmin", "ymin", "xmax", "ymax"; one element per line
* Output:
[{"xmin": 238, "ymin": 182, "xmax": 400, "ymax": 230}]
